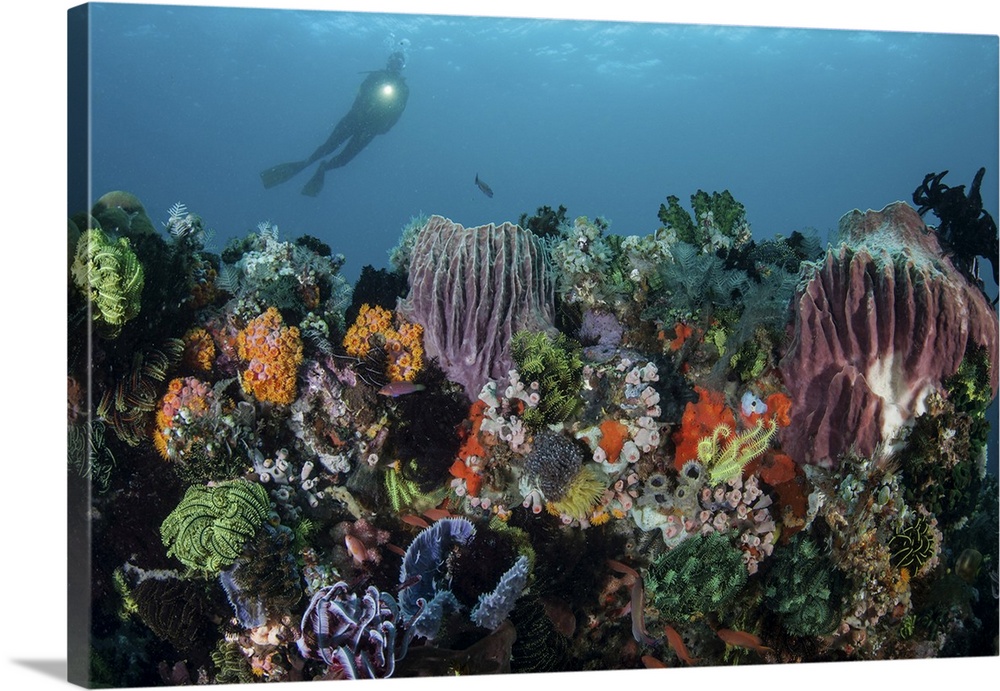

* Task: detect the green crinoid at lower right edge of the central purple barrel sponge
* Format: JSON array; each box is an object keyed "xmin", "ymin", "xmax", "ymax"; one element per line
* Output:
[{"xmin": 511, "ymin": 331, "xmax": 583, "ymax": 429}]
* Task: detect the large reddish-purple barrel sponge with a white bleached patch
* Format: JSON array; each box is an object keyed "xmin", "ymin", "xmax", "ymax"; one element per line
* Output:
[{"xmin": 780, "ymin": 202, "xmax": 1000, "ymax": 466}]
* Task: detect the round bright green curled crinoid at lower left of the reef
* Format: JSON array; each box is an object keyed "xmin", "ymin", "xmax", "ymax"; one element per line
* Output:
[{"xmin": 160, "ymin": 480, "xmax": 271, "ymax": 574}]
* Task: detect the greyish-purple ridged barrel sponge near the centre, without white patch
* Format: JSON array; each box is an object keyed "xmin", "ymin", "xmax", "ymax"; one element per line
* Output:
[{"xmin": 399, "ymin": 216, "xmax": 555, "ymax": 400}]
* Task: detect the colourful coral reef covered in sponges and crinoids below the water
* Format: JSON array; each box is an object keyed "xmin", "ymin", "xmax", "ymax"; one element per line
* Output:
[{"xmin": 67, "ymin": 185, "xmax": 1000, "ymax": 686}]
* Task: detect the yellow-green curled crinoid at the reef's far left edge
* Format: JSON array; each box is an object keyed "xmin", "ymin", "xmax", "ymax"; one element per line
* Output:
[{"xmin": 71, "ymin": 228, "xmax": 145, "ymax": 338}]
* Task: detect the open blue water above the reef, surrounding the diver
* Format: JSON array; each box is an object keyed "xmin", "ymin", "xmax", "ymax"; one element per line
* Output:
[{"xmin": 91, "ymin": 4, "xmax": 1000, "ymax": 286}]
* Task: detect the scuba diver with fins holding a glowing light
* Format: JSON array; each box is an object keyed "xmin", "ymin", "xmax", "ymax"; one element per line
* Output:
[{"xmin": 260, "ymin": 51, "xmax": 410, "ymax": 197}]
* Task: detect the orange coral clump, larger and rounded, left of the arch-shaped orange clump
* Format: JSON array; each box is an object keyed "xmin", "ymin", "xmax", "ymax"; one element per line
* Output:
[{"xmin": 236, "ymin": 307, "xmax": 302, "ymax": 405}]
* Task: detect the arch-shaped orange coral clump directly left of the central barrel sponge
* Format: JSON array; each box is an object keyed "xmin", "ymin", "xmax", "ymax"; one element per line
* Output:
[{"xmin": 344, "ymin": 304, "xmax": 424, "ymax": 381}]
